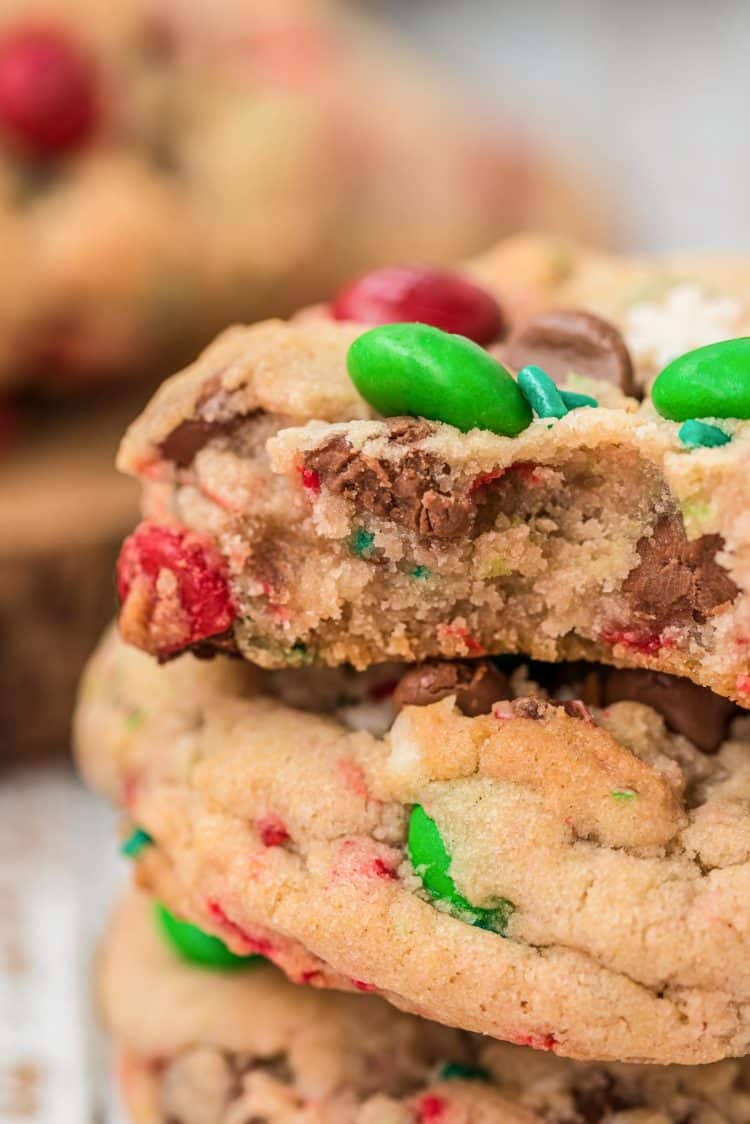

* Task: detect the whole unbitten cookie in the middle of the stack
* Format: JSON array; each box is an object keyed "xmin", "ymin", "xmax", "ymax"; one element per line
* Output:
[{"xmin": 76, "ymin": 634, "xmax": 750, "ymax": 1064}]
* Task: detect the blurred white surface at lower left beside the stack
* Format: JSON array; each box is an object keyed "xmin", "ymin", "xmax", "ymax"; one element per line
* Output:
[{"xmin": 0, "ymin": 764, "xmax": 121, "ymax": 1124}]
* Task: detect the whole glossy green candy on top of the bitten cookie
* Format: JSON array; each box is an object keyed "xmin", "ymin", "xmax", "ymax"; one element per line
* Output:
[{"xmin": 346, "ymin": 324, "xmax": 532, "ymax": 437}]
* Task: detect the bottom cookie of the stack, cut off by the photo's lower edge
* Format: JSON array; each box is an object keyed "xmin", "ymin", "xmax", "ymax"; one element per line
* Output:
[{"xmin": 98, "ymin": 895, "xmax": 749, "ymax": 1124}]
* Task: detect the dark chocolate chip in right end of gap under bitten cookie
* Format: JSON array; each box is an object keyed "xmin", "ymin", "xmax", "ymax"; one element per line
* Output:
[{"xmin": 604, "ymin": 669, "xmax": 737, "ymax": 753}]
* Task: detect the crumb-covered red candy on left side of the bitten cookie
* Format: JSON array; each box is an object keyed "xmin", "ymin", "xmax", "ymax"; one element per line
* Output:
[{"xmin": 117, "ymin": 523, "xmax": 236, "ymax": 655}]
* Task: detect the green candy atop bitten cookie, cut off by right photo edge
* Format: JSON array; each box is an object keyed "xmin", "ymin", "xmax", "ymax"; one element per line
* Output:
[{"xmin": 651, "ymin": 336, "xmax": 750, "ymax": 422}]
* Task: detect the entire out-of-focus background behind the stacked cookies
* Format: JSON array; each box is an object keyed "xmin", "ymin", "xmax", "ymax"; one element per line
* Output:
[{"xmin": 0, "ymin": 0, "xmax": 750, "ymax": 1124}]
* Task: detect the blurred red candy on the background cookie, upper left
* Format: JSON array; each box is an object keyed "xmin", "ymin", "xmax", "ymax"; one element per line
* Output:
[{"xmin": 0, "ymin": 27, "xmax": 99, "ymax": 156}]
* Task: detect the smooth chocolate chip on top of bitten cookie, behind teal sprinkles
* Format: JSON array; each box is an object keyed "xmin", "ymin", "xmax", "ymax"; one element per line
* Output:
[{"xmin": 505, "ymin": 308, "xmax": 638, "ymax": 396}]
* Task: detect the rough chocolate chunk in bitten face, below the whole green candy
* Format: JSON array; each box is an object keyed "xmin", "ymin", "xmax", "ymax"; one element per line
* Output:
[{"xmin": 304, "ymin": 418, "xmax": 477, "ymax": 541}]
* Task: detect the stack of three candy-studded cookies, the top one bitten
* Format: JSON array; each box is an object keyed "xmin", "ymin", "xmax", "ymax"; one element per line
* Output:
[{"xmin": 76, "ymin": 238, "xmax": 750, "ymax": 1124}]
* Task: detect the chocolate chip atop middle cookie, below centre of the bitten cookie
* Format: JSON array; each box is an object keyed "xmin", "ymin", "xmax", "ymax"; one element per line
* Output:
[{"xmin": 394, "ymin": 660, "xmax": 510, "ymax": 718}]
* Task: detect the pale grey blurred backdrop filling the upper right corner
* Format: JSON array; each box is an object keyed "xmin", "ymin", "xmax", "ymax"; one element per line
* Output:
[{"xmin": 382, "ymin": 0, "xmax": 750, "ymax": 252}]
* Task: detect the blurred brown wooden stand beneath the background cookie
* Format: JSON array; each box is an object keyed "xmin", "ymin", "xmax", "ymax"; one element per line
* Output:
[{"xmin": 0, "ymin": 404, "xmax": 137, "ymax": 764}]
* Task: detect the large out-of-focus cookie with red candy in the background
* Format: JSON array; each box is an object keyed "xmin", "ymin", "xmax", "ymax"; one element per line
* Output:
[{"xmin": 0, "ymin": 0, "xmax": 604, "ymax": 392}]
